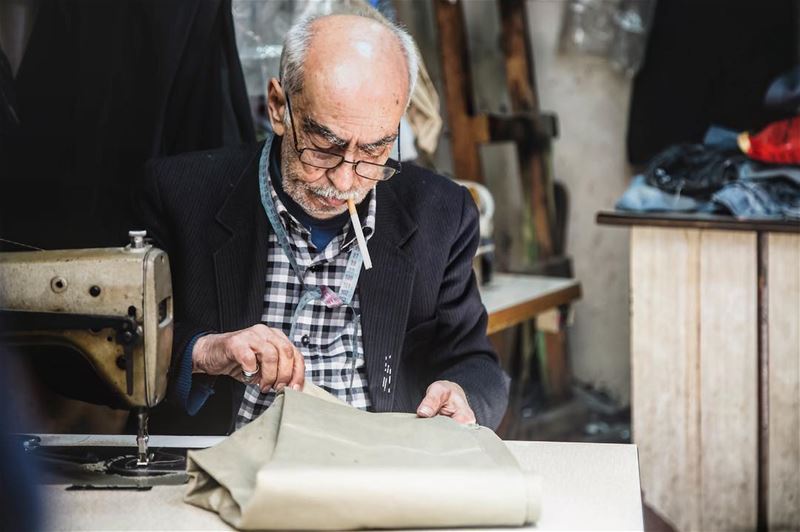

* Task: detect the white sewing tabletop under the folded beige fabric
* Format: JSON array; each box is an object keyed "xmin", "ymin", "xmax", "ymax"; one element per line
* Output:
[{"xmin": 42, "ymin": 436, "xmax": 643, "ymax": 531}]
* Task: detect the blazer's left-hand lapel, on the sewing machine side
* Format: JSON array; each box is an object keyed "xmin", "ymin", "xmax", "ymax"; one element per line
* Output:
[{"xmin": 214, "ymin": 144, "xmax": 270, "ymax": 331}]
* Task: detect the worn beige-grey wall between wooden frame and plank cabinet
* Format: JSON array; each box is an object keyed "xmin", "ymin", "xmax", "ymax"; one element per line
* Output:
[{"xmin": 528, "ymin": 0, "xmax": 631, "ymax": 404}]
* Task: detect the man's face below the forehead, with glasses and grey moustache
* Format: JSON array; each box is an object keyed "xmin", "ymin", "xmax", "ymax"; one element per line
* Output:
[{"xmin": 281, "ymin": 91, "xmax": 397, "ymax": 219}]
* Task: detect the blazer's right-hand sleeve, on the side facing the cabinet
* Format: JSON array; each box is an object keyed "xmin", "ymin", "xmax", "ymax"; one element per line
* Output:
[{"xmin": 434, "ymin": 187, "xmax": 509, "ymax": 429}]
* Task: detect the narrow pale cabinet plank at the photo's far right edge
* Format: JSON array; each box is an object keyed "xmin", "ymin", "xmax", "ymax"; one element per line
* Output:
[{"xmin": 767, "ymin": 234, "xmax": 800, "ymax": 530}]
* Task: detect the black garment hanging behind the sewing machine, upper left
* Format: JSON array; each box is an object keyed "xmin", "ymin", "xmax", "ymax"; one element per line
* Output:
[{"xmin": 0, "ymin": 0, "xmax": 255, "ymax": 249}]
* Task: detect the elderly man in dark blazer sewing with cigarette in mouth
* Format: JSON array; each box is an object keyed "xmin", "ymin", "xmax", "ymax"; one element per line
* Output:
[{"xmin": 143, "ymin": 14, "xmax": 508, "ymax": 434}]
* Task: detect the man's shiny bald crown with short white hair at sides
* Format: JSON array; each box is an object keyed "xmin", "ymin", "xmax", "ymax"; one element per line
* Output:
[{"xmin": 281, "ymin": 12, "xmax": 418, "ymax": 108}]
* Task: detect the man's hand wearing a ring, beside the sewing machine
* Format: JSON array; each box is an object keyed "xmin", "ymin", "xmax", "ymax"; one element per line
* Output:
[{"xmin": 192, "ymin": 323, "xmax": 305, "ymax": 392}]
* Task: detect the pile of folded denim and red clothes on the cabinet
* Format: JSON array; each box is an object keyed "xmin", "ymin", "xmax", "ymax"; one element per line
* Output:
[{"xmin": 616, "ymin": 67, "xmax": 800, "ymax": 220}]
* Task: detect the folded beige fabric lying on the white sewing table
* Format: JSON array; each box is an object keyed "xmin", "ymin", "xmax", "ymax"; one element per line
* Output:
[{"xmin": 184, "ymin": 383, "xmax": 541, "ymax": 530}]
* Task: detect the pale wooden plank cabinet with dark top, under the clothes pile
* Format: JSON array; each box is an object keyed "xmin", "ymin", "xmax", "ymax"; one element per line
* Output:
[{"xmin": 598, "ymin": 214, "xmax": 800, "ymax": 530}]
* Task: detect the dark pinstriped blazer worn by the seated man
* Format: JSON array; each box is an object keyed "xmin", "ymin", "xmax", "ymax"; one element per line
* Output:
[{"xmin": 141, "ymin": 140, "xmax": 508, "ymax": 434}]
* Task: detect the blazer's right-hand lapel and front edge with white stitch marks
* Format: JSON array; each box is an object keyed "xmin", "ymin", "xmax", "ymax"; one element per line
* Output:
[{"xmin": 359, "ymin": 184, "xmax": 416, "ymax": 412}]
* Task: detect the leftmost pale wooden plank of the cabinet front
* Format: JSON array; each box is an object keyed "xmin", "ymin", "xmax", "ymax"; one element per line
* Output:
[{"xmin": 630, "ymin": 227, "xmax": 701, "ymax": 530}]
